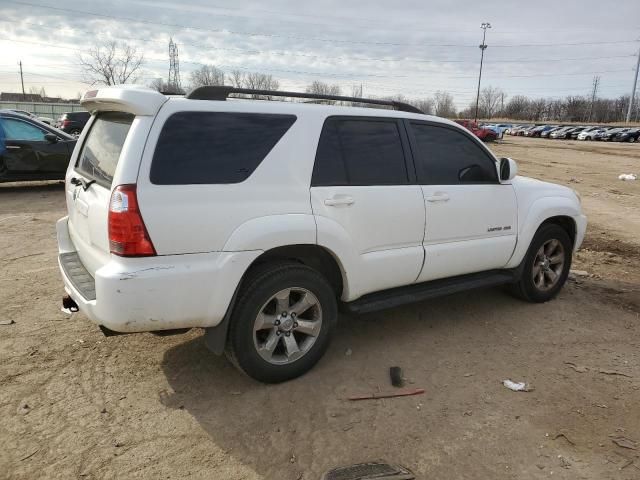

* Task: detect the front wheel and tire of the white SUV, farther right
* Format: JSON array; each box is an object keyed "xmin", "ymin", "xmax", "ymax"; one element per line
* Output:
[{"xmin": 512, "ymin": 224, "xmax": 573, "ymax": 303}]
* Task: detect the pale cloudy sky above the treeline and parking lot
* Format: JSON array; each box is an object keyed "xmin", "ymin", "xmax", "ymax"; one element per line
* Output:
[{"xmin": 0, "ymin": 0, "xmax": 640, "ymax": 108}]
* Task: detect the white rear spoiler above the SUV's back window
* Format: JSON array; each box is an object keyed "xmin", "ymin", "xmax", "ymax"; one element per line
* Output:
[{"xmin": 80, "ymin": 85, "xmax": 168, "ymax": 116}]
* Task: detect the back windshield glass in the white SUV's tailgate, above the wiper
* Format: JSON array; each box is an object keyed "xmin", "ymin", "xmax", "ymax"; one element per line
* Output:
[{"xmin": 76, "ymin": 112, "xmax": 134, "ymax": 187}]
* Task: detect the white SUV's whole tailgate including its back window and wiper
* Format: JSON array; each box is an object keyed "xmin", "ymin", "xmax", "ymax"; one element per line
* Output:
[{"xmin": 66, "ymin": 112, "xmax": 135, "ymax": 275}]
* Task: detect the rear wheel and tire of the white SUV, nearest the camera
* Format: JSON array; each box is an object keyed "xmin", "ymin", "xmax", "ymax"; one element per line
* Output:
[{"xmin": 225, "ymin": 262, "xmax": 338, "ymax": 383}]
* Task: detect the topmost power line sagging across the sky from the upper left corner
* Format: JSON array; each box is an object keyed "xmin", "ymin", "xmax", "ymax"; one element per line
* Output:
[{"xmin": 6, "ymin": 0, "xmax": 636, "ymax": 48}]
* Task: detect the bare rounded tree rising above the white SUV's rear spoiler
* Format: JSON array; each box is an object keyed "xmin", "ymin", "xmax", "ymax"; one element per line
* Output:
[{"xmin": 79, "ymin": 41, "xmax": 144, "ymax": 85}]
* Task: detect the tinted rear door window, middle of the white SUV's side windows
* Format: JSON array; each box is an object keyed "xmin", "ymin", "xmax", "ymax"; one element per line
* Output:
[{"xmin": 311, "ymin": 118, "xmax": 408, "ymax": 186}]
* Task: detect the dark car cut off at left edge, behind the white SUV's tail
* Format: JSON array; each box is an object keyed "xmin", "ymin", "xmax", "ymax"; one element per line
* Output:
[{"xmin": 0, "ymin": 110, "xmax": 76, "ymax": 182}]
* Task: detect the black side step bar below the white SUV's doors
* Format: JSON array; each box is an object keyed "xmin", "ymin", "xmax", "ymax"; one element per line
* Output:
[{"xmin": 342, "ymin": 270, "xmax": 517, "ymax": 314}]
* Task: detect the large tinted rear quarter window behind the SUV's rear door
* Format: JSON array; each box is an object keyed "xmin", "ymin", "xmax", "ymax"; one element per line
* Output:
[{"xmin": 151, "ymin": 112, "xmax": 296, "ymax": 185}]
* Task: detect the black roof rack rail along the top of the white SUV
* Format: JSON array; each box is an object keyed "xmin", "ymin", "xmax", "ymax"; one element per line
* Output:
[{"xmin": 185, "ymin": 85, "xmax": 424, "ymax": 114}]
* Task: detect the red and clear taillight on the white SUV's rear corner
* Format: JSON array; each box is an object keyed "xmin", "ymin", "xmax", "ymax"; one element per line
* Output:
[{"xmin": 109, "ymin": 185, "xmax": 156, "ymax": 257}]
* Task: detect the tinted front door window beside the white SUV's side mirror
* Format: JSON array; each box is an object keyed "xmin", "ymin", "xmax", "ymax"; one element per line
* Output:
[{"xmin": 411, "ymin": 122, "xmax": 498, "ymax": 185}]
